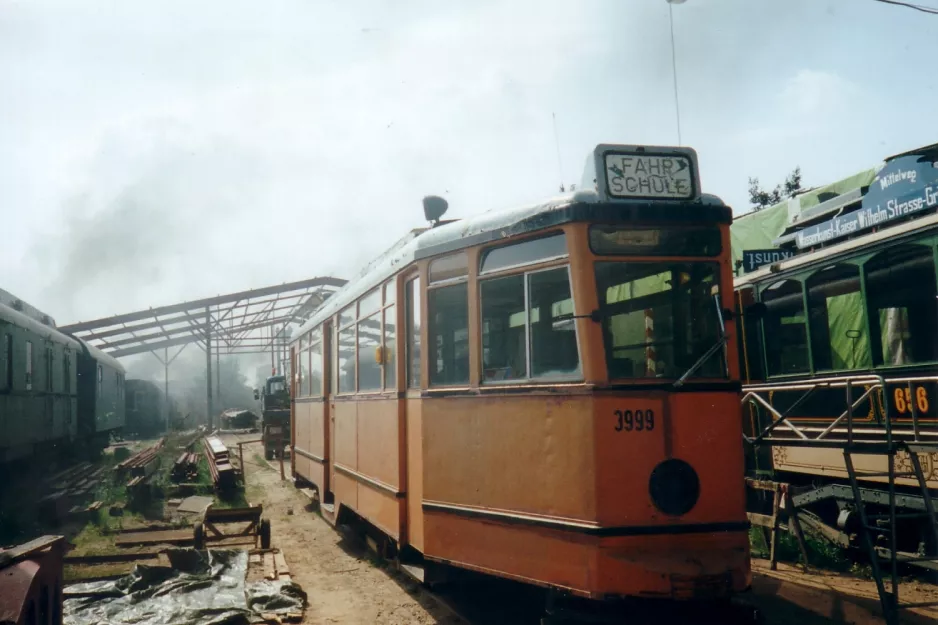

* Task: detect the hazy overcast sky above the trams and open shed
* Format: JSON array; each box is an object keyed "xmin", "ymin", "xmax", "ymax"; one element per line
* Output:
[{"xmin": 0, "ymin": 0, "xmax": 938, "ymax": 324}]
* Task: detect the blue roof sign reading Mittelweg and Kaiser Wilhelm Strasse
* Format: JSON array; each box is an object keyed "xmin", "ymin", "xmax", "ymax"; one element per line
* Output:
[{"xmin": 795, "ymin": 155, "xmax": 938, "ymax": 249}]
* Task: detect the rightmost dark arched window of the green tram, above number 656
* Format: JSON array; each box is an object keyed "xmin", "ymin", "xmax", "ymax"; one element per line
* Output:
[{"xmin": 863, "ymin": 244, "xmax": 938, "ymax": 366}]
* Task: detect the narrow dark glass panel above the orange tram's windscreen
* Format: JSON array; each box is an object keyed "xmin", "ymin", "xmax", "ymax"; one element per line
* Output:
[{"xmin": 590, "ymin": 225, "xmax": 723, "ymax": 256}]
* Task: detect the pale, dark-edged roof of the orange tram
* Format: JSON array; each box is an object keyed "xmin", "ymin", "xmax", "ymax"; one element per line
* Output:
[{"xmin": 291, "ymin": 188, "xmax": 732, "ymax": 343}]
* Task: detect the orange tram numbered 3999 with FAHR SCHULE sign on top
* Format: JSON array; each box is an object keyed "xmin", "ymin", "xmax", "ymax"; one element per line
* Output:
[{"xmin": 291, "ymin": 145, "xmax": 751, "ymax": 620}]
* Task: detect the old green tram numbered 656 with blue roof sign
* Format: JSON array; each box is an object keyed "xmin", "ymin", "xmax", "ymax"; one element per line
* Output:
[{"xmin": 732, "ymin": 144, "xmax": 938, "ymax": 554}]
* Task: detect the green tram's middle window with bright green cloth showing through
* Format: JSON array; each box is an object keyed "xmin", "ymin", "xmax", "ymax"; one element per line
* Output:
[{"xmin": 804, "ymin": 261, "xmax": 873, "ymax": 371}]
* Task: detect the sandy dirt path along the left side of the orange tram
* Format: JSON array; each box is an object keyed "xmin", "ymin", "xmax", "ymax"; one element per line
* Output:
[{"xmin": 234, "ymin": 444, "xmax": 462, "ymax": 625}]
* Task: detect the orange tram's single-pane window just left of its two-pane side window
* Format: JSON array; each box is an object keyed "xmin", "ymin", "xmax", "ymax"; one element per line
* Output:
[{"xmin": 427, "ymin": 283, "xmax": 469, "ymax": 385}]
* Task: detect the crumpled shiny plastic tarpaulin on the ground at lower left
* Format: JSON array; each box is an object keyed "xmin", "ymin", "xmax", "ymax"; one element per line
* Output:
[{"xmin": 64, "ymin": 549, "xmax": 306, "ymax": 625}]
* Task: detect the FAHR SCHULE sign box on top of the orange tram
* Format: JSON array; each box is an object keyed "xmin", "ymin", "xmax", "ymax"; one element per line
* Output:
[{"xmin": 583, "ymin": 144, "xmax": 700, "ymax": 202}]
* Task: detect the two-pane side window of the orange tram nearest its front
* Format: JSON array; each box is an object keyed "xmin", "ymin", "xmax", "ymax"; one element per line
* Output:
[{"xmin": 480, "ymin": 267, "xmax": 580, "ymax": 382}]
